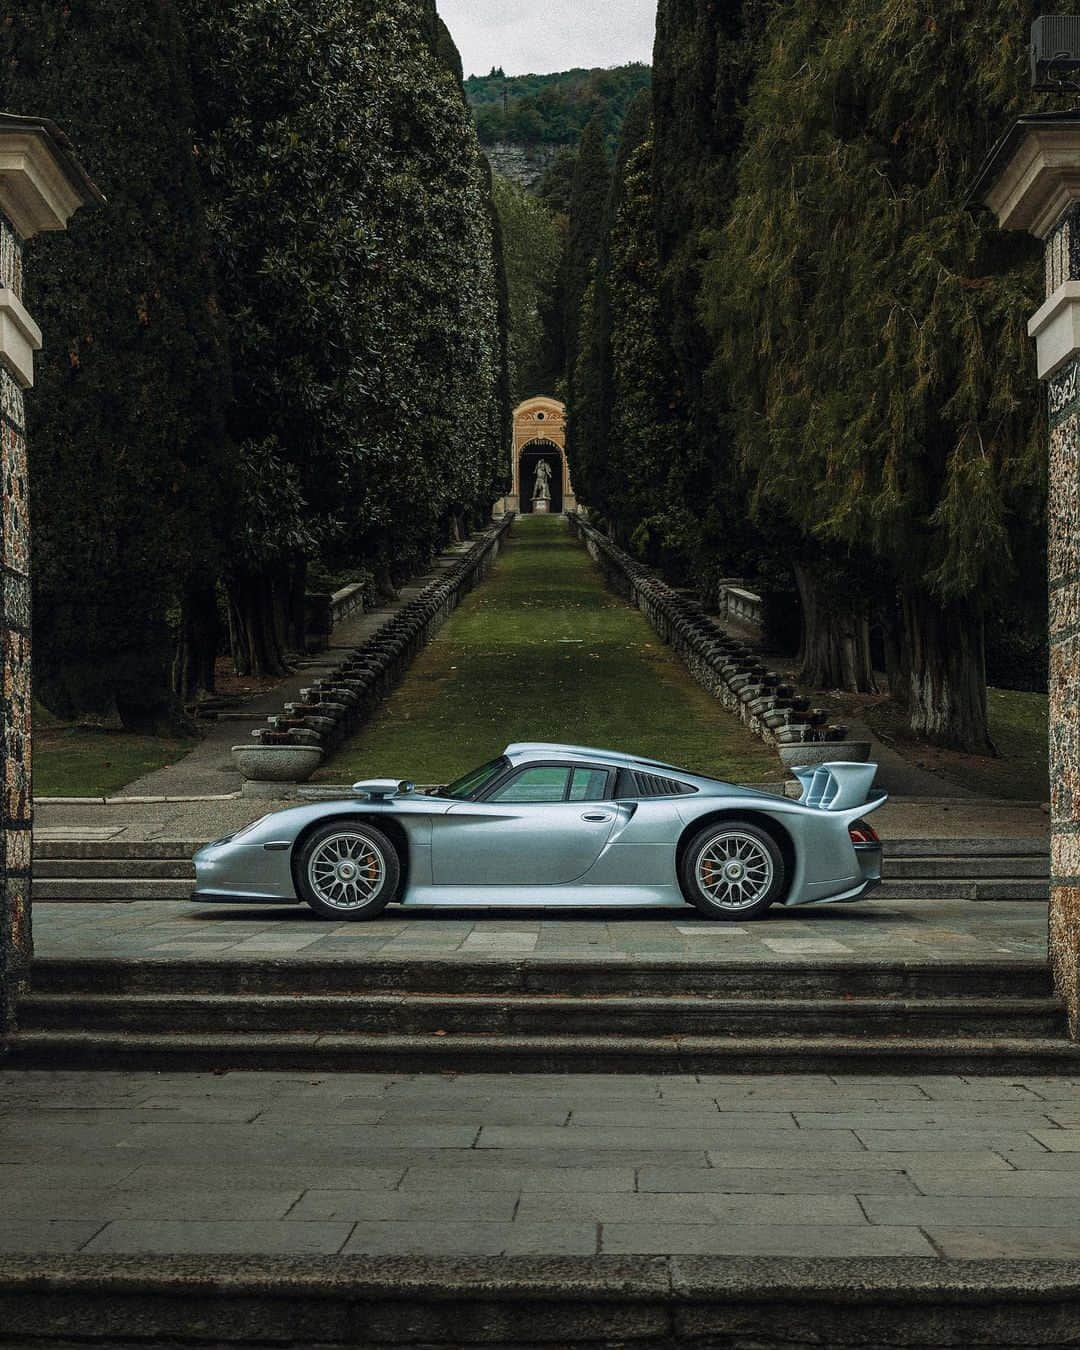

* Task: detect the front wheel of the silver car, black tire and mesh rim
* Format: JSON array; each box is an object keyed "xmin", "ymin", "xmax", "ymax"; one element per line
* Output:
[{"xmin": 293, "ymin": 821, "xmax": 401, "ymax": 923}]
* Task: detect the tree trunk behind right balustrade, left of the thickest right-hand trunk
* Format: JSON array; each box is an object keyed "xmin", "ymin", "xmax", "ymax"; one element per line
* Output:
[{"xmin": 794, "ymin": 563, "xmax": 878, "ymax": 694}]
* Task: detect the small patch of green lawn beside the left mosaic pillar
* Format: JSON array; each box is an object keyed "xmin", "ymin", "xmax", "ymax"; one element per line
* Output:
[{"xmin": 34, "ymin": 707, "xmax": 196, "ymax": 797}]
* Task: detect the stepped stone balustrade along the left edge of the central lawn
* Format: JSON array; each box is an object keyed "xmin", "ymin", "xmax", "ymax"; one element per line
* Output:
[{"xmin": 232, "ymin": 513, "xmax": 514, "ymax": 791}]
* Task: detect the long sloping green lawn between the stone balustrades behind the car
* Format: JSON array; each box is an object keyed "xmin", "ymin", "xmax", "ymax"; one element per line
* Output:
[{"xmin": 316, "ymin": 516, "xmax": 784, "ymax": 783}]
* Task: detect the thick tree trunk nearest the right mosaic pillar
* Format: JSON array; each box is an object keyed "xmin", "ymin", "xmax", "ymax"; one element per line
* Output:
[{"xmin": 902, "ymin": 590, "xmax": 998, "ymax": 755}]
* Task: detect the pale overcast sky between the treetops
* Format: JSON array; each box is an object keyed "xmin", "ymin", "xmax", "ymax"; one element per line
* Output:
[{"xmin": 439, "ymin": 0, "xmax": 656, "ymax": 76}]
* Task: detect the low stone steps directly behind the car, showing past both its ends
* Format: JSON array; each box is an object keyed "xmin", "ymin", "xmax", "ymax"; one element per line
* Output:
[{"xmin": 34, "ymin": 838, "xmax": 1050, "ymax": 903}]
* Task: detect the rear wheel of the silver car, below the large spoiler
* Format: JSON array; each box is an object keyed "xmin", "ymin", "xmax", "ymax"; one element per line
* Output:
[{"xmin": 679, "ymin": 819, "xmax": 787, "ymax": 923}]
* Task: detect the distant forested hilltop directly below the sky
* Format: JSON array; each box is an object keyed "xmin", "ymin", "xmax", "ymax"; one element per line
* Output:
[{"xmin": 464, "ymin": 65, "xmax": 649, "ymax": 149}]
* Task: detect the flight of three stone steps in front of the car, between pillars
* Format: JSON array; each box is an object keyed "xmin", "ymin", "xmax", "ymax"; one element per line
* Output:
[{"xmin": 12, "ymin": 957, "xmax": 1080, "ymax": 1075}]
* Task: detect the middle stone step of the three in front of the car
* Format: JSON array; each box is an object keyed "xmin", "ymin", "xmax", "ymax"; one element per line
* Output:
[{"xmin": 19, "ymin": 992, "xmax": 1080, "ymax": 1042}]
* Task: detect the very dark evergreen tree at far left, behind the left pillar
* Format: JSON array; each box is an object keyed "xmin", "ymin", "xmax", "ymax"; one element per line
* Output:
[{"xmin": 0, "ymin": 0, "xmax": 231, "ymax": 730}]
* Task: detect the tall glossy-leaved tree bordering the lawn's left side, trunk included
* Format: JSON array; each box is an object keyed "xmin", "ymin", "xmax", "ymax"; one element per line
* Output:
[{"xmin": 184, "ymin": 0, "xmax": 508, "ymax": 671}]
